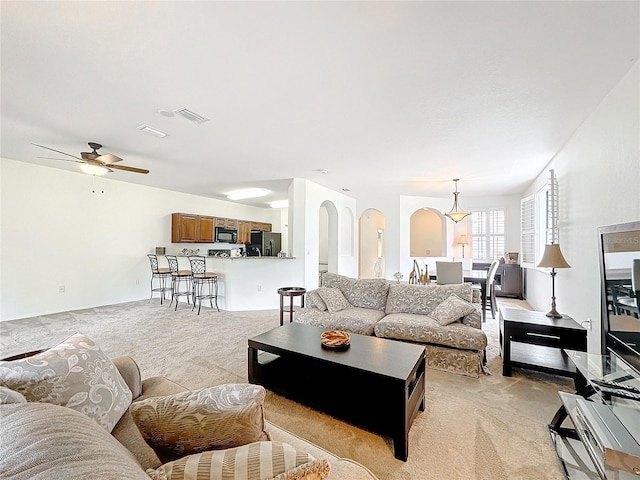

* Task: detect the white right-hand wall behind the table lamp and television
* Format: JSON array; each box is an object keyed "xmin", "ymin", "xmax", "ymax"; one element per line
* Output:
[{"xmin": 526, "ymin": 62, "xmax": 640, "ymax": 352}]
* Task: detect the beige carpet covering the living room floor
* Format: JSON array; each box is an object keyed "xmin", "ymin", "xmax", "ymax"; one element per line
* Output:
[{"xmin": 0, "ymin": 300, "xmax": 572, "ymax": 480}]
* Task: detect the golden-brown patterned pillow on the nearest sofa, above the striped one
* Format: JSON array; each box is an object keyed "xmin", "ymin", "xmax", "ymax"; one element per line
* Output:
[{"xmin": 129, "ymin": 383, "xmax": 271, "ymax": 462}]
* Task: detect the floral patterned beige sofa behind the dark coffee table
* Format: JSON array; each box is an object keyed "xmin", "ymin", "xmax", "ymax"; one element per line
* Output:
[{"xmin": 294, "ymin": 273, "xmax": 487, "ymax": 377}]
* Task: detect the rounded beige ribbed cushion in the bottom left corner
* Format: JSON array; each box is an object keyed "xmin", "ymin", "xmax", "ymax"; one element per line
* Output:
[{"xmin": 0, "ymin": 403, "xmax": 149, "ymax": 480}]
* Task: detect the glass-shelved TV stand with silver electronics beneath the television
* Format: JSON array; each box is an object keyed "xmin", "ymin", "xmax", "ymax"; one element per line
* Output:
[{"xmin": 549, "ymin": 350, "xmax": 640, "ymax": 480}]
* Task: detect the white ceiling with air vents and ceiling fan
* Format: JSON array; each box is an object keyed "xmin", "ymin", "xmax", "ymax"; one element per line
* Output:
[{"xmin": 1, "ymin": 1, "xmax": 640, "ymax": 205}]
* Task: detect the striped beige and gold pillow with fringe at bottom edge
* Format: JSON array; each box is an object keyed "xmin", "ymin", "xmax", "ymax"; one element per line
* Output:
[{"xmin": 147, "ymin": 442, "xmax": 330, "ymax": 480}]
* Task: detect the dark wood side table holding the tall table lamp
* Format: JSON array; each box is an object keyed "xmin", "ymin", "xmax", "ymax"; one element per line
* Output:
[{"xmin": 500, "ymin": 308, "xmax": 587, "ymax": 380}]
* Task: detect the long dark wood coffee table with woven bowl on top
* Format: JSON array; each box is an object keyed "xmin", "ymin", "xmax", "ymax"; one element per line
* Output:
[{"xmin": 249, "ymin": 323, "xmax": 426, "ymax": 461}]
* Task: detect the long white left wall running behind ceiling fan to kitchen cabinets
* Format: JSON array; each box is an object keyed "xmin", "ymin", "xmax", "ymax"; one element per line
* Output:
[{"xmin": 0, "ymin": 159, "xmax": 282, "ymax": 320}]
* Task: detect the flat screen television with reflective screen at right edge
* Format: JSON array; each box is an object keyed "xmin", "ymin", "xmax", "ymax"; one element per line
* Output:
[{"xmin": 598, "ymin": 221, "xmax": 640, "ymax": 372}]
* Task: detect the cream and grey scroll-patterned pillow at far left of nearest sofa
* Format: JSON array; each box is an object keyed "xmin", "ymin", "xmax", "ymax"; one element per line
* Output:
[{"xmin": 0, "ymin": 333, "xmax": 131, "ymax": 432}]
